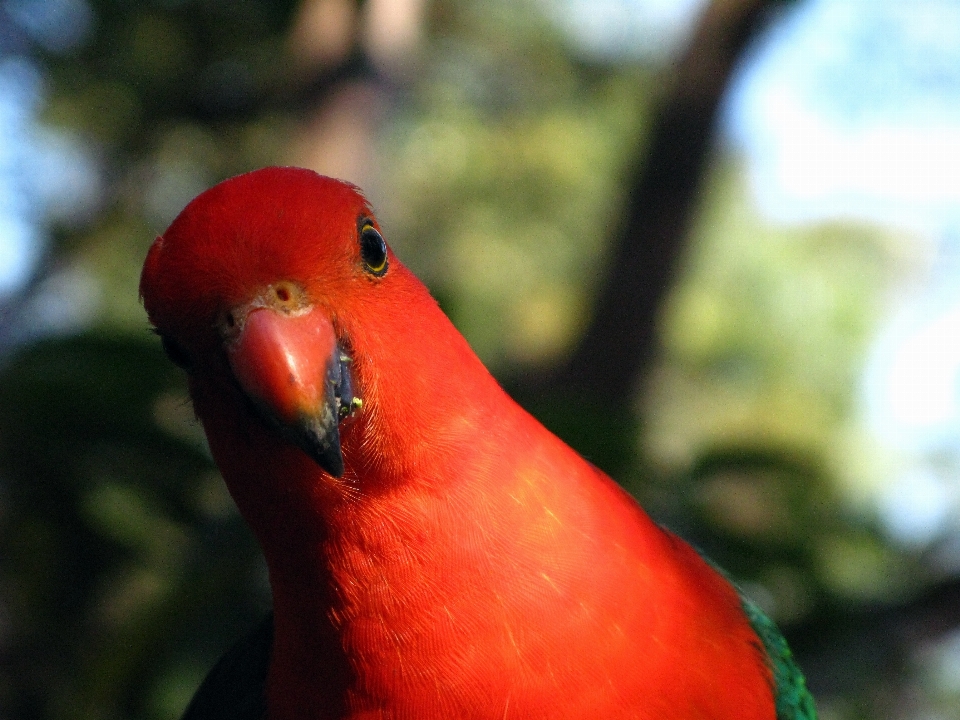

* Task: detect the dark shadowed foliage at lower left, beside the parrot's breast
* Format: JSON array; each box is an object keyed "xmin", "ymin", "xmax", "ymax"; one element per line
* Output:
[{"xmin": 0, "ymin": 335, "xmax": 268, "ymax": 720}]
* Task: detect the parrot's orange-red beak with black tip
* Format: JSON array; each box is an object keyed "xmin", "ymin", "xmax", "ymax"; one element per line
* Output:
[{"xmin": 226, "ymin": 306, "xmax": 356, "ymax": 477}]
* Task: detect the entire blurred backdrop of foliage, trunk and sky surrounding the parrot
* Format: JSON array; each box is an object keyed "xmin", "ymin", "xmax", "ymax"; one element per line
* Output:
[{"xmin": 0, "ymin": 0, "xmax": 960, "ymax": 720}]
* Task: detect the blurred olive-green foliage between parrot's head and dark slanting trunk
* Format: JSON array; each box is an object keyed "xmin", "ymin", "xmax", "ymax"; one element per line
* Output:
[{"xmin": 380, "ymin": 2, "xmax": 653, "ymax": 370}]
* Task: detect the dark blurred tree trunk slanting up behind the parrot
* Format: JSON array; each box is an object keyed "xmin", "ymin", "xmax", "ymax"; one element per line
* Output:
[{"xmin": 534, "ymin": 0, "xmax": 779, "ymax": 404}]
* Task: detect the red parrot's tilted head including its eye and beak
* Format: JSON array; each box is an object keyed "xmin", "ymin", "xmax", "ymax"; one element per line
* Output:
[{"xmin": 140, "ymin": 168, "xmax": 400, "ymax": 477}]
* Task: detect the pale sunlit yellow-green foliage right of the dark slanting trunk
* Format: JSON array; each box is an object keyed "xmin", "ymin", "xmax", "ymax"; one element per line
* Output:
[{"xmin": 645, "ymin": 164, "xmax": 908, "ymax": 482}]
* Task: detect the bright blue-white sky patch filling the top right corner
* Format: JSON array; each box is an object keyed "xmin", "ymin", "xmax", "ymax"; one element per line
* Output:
[{"xmin": 724, "ymin": 0, "xmax": 960, "ymax": 235}]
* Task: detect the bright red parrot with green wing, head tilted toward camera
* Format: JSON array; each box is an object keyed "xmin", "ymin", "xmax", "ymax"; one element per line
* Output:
[{"xmin": 140, "ymin": 168, "xmax": 815, "ymax": 720}]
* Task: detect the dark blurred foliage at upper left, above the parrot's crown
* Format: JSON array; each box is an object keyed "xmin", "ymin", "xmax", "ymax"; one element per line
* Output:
[{"xmin": 36, "ymin": 0, "xmax": 296, "ymax": 330}]
